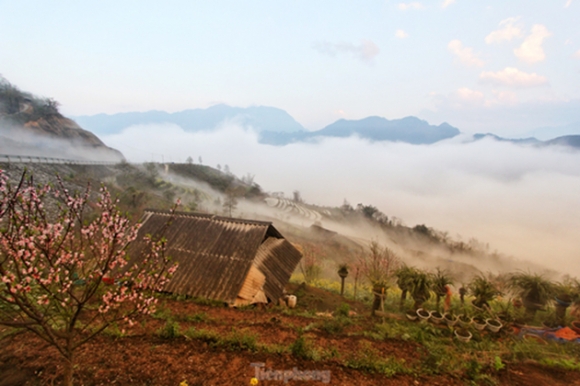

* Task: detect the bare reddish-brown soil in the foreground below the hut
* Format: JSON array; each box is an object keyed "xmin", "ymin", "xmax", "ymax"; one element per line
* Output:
[{"xmin": 0, "ymin": 292, "xmax": 580, "ymax": 386}]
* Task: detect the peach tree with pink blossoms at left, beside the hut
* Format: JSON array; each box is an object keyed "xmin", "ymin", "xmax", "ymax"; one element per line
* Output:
[{"xmin": 0, "ymin": 170, "xmax": 176, "ymax": 385}]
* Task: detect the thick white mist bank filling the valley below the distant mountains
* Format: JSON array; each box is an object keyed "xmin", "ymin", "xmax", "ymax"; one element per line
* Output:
[{"xmin": 102, "ymin": 125, "xmax": 580, "ymax": 275}]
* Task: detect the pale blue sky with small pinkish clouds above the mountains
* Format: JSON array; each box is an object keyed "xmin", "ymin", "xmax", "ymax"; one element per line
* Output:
[{"xmin": 0, "ymin": 0, "xmax": 580, "ymax": 137}]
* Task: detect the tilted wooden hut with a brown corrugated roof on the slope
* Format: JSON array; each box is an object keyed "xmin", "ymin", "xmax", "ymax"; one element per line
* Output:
[{"xmin": 128, "ymin": 210, "xmax": 302, "ymax": 306}]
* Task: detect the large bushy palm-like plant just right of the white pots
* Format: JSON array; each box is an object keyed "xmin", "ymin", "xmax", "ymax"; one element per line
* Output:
[{"xmin": 509, "ymin": 272, "xmax": 557, "ymax": 320}]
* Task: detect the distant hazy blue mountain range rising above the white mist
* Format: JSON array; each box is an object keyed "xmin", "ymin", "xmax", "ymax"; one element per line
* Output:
[{"xmin": 74, "ymin": 104, "xmax": 580, "ymax": 148}]
